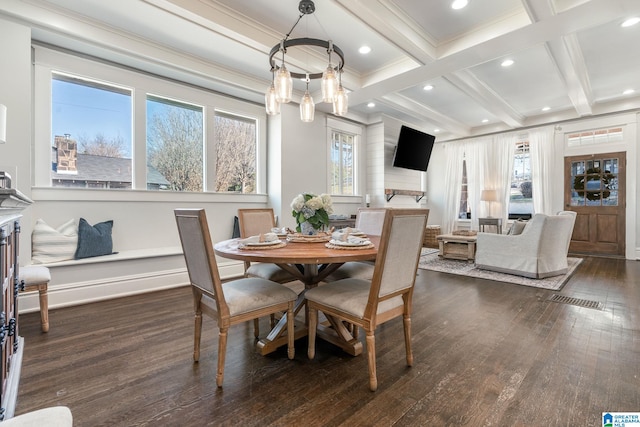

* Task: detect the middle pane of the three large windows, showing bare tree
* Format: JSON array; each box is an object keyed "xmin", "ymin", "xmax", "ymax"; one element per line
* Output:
[{"xmin": 147, "ymin": 96, "xmax": 204, "ymax": 191}]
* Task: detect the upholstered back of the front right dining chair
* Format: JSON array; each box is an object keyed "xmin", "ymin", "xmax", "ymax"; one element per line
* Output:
[{"xmin": 365, "ymin": 209, "xmax": 429, "ymax": 310}]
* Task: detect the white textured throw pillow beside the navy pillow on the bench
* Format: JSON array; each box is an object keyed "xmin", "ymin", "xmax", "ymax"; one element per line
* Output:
[{"xmin": 31, "ymin": 219, "xmax": 78, "ymax": 264}]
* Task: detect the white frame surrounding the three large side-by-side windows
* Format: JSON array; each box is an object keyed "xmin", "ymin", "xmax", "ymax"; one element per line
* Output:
[{"xmin": 34, "ymin": 45, "xmax": 267, "ymax": 199}]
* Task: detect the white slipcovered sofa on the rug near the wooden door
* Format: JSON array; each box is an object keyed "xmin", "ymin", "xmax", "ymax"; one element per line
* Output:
[{"xmin": 475, "ymin": 211, "xmax": 576, "ymax": 279}]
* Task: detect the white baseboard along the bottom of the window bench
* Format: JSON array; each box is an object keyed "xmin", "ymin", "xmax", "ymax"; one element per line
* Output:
[{"xmin": 18, "ymin": 261, "xmax": 244, "ymax": 313}]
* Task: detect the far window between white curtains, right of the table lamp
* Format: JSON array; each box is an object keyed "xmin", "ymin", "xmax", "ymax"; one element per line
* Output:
[{"xmin": 509, "ymin": 142, "xmax": 533, "ymax": 217}]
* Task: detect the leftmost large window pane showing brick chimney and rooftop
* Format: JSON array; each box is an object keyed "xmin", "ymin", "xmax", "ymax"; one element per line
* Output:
[{"xmin": 51, "ymin": 73, "xmax": 132, "ymax": 189}]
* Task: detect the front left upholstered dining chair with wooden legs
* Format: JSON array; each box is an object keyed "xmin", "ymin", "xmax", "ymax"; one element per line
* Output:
[{"xmin": 174, "ymin": 209, "xmax": 298, "ymax": 387}]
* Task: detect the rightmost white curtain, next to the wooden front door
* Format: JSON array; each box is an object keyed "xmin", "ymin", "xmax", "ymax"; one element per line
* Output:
[{"xmin": 528, "ymin": 128, "xmax": 554, "ymax": 215}]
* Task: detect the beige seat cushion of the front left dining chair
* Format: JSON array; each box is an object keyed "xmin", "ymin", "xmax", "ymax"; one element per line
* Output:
[{"xmin": 222, "ymin": 277, "xmax": 298, "ymax": 316}]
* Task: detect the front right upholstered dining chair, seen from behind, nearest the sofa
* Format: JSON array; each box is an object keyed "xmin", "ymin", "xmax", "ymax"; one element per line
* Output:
[{"xmin": 305, "ymin": 209, "xmax": 429, "ymax": 391}]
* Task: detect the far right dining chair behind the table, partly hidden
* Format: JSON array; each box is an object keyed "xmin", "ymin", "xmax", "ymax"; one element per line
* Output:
[{"xmin": 324, "ymin": 208, "xmax": 387, "ymax": 282}]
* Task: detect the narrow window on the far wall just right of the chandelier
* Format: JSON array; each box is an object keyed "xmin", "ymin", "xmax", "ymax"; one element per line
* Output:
[{"xmin": 330, "ymin": 130, "xmax": 355, "ymax": 196}]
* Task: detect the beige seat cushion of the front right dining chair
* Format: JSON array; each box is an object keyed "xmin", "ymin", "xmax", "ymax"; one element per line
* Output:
[{"xmin": 305, "ymin": 279, "xmax": 404, "ymax": 318}]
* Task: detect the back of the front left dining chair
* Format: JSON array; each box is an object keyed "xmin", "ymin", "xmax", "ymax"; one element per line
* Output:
[{"xmin": 174, "ymin": 209, "xmax": 229, "ymax": 316}]
